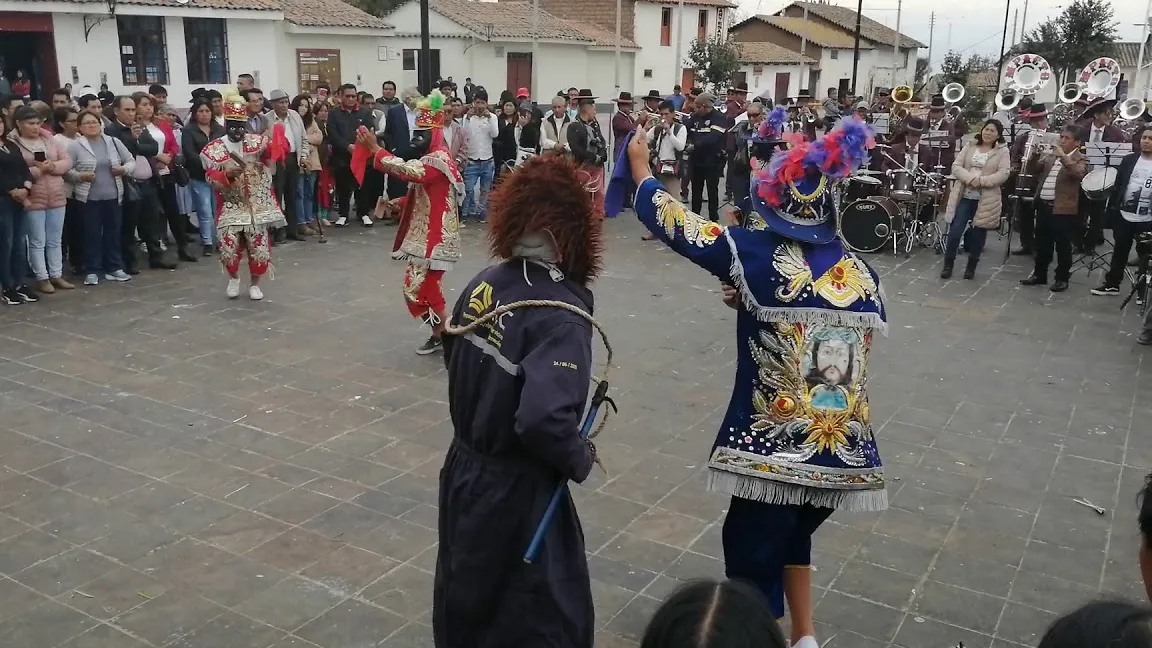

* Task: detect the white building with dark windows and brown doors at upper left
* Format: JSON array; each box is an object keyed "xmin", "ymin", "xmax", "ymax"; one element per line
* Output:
[{"xmin": 0, "ymin": 0, "xmax": 389, "ymax": 105}]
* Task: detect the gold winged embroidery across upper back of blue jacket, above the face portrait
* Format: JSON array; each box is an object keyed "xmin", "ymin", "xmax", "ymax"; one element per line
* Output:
[{"xmin": 772, "ymin": 242, "xmax": 877, "ymax": 308}]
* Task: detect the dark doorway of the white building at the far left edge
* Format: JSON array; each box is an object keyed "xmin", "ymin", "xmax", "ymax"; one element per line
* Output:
[{"xmin": 0, "ymin": 12, "xmax": 58, "ymax": 99}]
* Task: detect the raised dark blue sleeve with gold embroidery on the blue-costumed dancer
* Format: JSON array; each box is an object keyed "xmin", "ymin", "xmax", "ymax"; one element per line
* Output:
[{"xmin": 635, "ymin": 178, "xmax": 732, "ymax": 279}]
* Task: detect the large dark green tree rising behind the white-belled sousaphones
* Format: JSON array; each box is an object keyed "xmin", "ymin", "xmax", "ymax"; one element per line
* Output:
[{"xmin": 1006, "ymin": 0, "xmax": 1116, "ymax": 82}]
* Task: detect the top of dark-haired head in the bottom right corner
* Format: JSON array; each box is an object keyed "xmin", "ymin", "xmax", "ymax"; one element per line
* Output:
[{"xmin": 1037, "ymin": 601, "xmax": 1152, "ymax": 648}]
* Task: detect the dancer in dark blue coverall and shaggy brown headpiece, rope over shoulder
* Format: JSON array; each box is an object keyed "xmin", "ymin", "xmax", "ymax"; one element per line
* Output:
[{"xmin": 432, "ymin": 152, "xmax": 601, "ymax": 648}]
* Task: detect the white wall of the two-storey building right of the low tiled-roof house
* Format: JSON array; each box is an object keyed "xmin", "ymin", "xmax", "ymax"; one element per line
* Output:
[{"xmin": 624, "ymin": 2, "xmax": 727, "ymax": 95}]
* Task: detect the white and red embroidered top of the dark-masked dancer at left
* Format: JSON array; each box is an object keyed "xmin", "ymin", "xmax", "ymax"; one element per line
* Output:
[{"xmin": 200, "ymin": 133, "xmax": 287, "ymax": 235}]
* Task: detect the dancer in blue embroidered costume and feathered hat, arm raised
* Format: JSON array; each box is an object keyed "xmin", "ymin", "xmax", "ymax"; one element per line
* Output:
[{"xmin": 608, "ymin": 120, "xmax": 888, "ymax": 648}]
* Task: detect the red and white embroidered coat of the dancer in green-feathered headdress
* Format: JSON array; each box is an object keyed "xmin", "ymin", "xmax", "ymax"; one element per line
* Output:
[{"xmin": 374, "ymin": 148, "xmax": 464, "ymax": 270}]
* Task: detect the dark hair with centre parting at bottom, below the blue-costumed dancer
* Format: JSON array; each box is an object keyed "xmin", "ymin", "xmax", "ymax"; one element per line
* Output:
[{"xmin": 641, "ymin": 580, "xmax": 788, "ymax": 648}]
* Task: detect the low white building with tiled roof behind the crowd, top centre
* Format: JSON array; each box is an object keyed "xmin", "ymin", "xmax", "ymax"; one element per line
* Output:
[{"xmin": 379, "ymin": 0, "xmax": 638, "ymax": 103}]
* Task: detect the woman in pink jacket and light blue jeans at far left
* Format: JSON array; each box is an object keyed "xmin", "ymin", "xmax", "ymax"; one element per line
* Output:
[{"xmin": 8, "ymin": 106, "xmax": 74, "ymax": 294}]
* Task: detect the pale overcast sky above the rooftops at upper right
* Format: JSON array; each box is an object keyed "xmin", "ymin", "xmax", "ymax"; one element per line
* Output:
[{"xmin": 738, "ymin": 0, "xmax": 1149, "ymax": 69}]
